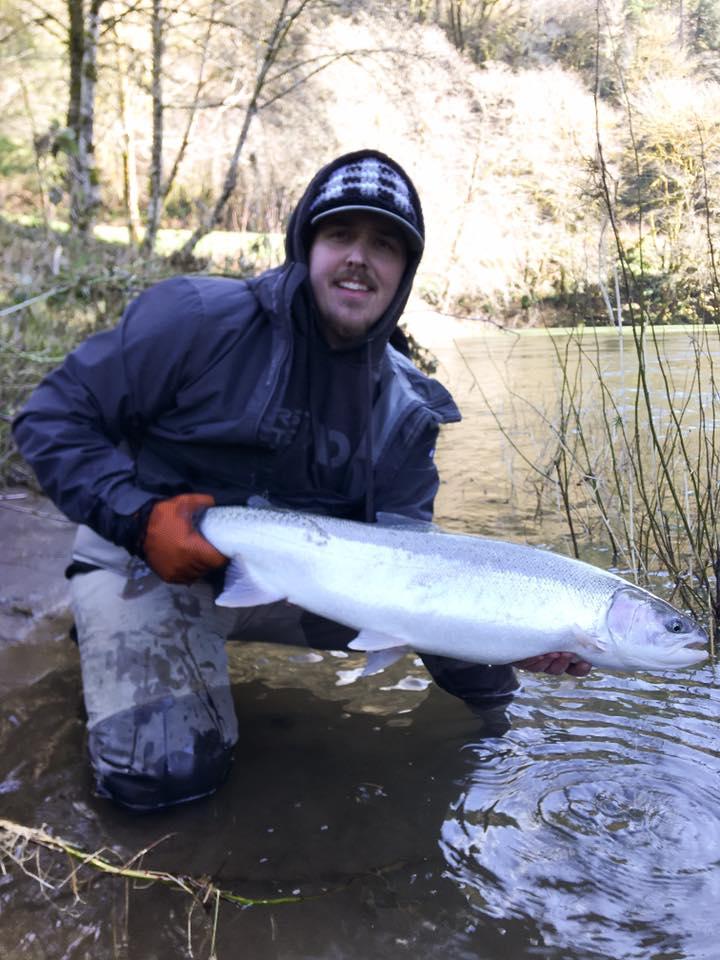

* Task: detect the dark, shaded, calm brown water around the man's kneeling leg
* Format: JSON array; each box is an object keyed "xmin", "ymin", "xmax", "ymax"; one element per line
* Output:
[{"xmin": 0, "ymin": 647, "xmax": 527, "ymax": 960}]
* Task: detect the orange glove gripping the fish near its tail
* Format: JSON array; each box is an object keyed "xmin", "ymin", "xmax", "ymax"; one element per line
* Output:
[{"xmin": 143, "ymin": 493, "xmax": 228, "ymax": 583}]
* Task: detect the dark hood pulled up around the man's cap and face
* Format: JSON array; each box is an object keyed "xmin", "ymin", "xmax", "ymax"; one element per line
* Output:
[{"xmin": 285, "ymin": 150, "xmax": 425, "ymax": 360}]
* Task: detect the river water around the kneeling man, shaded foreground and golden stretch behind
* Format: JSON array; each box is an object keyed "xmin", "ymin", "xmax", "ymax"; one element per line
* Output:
[{"xmin": 0, "ymin": 326, "xmax": 720, "ymax": 960}]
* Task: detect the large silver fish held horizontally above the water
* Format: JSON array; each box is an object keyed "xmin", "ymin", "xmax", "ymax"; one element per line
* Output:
[{"xmin": 199, "ymin": 507, "xmax": 707, "ymax": 672}]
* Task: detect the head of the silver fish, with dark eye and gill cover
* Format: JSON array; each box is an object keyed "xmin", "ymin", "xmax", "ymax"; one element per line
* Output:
[{"xmin": 598, "ymin": 586, "xmax": 708, "ymax": 670}]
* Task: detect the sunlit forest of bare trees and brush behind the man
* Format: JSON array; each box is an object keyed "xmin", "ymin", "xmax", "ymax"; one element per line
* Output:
[{"xmin": 0, "ymin": 0, "xmax": 720, "ymax": 488}]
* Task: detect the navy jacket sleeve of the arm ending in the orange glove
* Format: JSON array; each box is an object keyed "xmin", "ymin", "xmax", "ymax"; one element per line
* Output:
[{"xmin": 13, "ymin": 278, "xmax": 208, "ymax": 547}]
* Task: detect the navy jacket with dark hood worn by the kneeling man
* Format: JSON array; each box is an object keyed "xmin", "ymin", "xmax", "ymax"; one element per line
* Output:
[{"xmin": 13, "ymin": 151, "xmax": 460, "ymax": 551}]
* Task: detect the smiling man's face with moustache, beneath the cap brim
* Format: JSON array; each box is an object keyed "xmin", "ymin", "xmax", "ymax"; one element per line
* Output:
[{"xmin": 310, "ymin": 211, "xmax": 407, "ymax": 348}]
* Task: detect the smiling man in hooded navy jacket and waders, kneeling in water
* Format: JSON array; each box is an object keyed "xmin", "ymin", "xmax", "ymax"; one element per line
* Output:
[{"xmin": 14, "ymin": 150, "xmax": 584, "ymax": 810}]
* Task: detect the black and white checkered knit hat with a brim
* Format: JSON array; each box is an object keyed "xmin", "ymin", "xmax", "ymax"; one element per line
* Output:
[{"xmin": 309, "ymin": 156, "xmax": 425, "ymax": 253}]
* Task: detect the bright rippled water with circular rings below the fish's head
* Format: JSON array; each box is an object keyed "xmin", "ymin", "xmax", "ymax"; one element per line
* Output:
[{"xmin": 441, "ymin": 671, "xmax": 720, "ymax": 960}]
